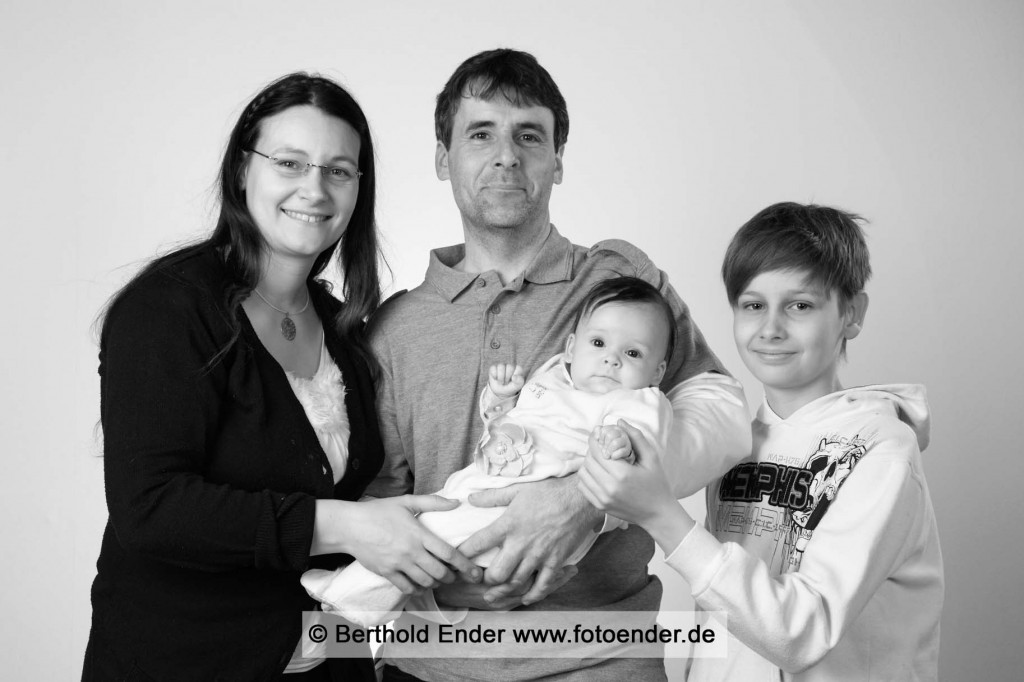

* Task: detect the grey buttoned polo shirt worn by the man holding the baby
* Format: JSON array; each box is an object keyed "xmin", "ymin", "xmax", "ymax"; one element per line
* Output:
[{"xmin": 368, "ymin": 227, "xmax": 723, "ymax": 681}]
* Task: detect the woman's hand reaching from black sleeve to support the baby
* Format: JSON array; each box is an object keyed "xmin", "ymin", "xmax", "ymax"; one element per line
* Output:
[{"xmin": 310, "ymin": 495, "xmax": 482, "ymax": 594}]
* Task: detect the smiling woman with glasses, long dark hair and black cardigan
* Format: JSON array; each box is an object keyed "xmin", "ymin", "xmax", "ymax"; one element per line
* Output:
[{"xmin": 83, "ymin": 74, "xmax": 473, "ymax": 682}]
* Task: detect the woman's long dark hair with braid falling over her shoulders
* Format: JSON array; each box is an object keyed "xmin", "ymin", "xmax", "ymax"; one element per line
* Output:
[{"xmin": 104, "ymin": 73, "xmax": 381, "ymax": 371}]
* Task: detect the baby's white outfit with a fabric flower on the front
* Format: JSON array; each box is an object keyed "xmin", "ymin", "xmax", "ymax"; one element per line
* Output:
[{"xmin": 302, "ymin": 353, "xmax": 672, "ymax": 627}]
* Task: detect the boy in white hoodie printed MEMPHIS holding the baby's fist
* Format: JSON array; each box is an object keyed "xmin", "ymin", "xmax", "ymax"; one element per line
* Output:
[{"xmin": 580, "ymin": 204, "xmax": 943, "ymax": 682}]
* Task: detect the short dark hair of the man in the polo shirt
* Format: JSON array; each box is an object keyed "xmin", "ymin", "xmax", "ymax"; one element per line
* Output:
[{"xmin": 434, "ymin": 48, "xmax": 569, "ymax": 151}]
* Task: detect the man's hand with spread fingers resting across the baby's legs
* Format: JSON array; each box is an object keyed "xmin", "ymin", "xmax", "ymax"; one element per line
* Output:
[{"xmin": 459, "ymin": 475, "xmax": 604, "ymax": 604}]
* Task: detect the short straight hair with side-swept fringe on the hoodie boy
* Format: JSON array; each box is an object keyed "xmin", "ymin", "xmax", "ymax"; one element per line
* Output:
[{"xmin": 722, "ymin": 202, "xmax": 871, "ymax": 310}]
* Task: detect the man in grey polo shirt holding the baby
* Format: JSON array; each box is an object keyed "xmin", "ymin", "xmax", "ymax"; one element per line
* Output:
[{"xmin": 369, "ymin": 49, "xmax": 750, "ymax": 682}]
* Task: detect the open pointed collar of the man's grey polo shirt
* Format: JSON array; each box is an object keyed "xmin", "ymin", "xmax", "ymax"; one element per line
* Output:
[{"xmin": 425, "ymin": 225, "xmax": 572, "ymax": 303}]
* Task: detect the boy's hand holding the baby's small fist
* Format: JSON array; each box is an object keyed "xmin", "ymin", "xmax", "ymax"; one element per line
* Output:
[{"xmin": 579, "ymin": 420, "xmax": 693, "ymax": 552}]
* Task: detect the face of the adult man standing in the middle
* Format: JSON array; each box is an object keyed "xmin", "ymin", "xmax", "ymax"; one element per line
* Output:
[{"xmin": 434, "ymin": 97, "xmax": 562, "ymax": 231}]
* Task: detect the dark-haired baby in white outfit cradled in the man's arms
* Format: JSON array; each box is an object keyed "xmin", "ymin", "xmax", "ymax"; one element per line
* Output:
[{"xmin": 302, "ymin": 276, "xmax": 675, "ymax": 626}]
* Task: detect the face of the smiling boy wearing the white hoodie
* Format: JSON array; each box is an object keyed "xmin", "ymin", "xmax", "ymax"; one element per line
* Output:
[{"xmin": 732, "ymin": 270, "xmax": 867, "ymax": 414}]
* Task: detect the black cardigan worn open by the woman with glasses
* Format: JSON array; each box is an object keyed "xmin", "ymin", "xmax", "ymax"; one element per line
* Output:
[{"xmin": 84, "ymin": 247, "xmax": 383, "ymax": 682}]
